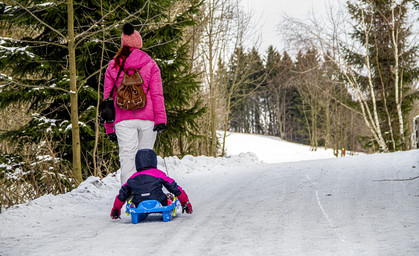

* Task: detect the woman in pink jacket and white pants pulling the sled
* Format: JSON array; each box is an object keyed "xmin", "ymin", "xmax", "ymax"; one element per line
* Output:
[{"xmin": 103, "ymin": 23, "xmax": 167, "ymax": 184}]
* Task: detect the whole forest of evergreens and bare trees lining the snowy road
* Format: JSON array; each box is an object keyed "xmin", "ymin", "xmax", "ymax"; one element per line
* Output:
[{"xmin": 0, "ymin": 0, "xmax": 419, "ymax": 211}]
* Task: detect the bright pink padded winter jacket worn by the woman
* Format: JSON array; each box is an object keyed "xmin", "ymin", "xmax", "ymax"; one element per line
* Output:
[{"xmin": 103, "ymin": 49, "xmax": 167, "ymax": 134}]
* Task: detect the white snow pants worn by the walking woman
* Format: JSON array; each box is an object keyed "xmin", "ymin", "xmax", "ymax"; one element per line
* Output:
[{"xmin": 115, "ymin": 119, "xmax": 157, "ymax": 185}]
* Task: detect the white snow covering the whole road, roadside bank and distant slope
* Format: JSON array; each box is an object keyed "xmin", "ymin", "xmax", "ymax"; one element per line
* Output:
[{"xmin": 0, "ymin": 133, "xmax": 419, "ymax": 256}]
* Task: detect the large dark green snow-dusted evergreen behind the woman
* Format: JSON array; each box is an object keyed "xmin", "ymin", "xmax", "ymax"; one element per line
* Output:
[{"xmin": 0, "ymin": 0, "xmax": 204, "ymax": 180}]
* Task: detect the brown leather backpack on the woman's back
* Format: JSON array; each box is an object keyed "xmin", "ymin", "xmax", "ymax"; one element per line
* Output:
[{"xmin": 116, "ymin": 67, "xmax": 147, "ymax": 110}]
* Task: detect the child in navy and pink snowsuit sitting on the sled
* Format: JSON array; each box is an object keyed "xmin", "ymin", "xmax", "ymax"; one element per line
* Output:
[{"xmin": 111, "ymin": 149, "xmax": 192, "ymax": 219}]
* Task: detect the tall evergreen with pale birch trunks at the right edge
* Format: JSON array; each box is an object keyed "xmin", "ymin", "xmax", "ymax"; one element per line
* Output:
[{"xmin": 347, "ymin": 0, "xmax": 419, "ymax": 151}]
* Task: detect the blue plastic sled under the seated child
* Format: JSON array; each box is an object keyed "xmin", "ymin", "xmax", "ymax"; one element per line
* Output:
[{"xmin": 126, "ymin": 198, "xmax": 180, "ymax": 224}]
